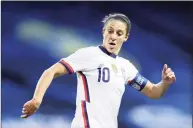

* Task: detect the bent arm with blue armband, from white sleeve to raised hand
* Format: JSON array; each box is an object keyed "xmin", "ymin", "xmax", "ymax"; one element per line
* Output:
[{"xmin": 126, "ymin": 64, "xmax": 176, "ymax": 99}]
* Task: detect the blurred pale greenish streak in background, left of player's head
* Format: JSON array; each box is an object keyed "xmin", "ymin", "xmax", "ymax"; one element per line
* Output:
[{"xmin": 16, "ymin": 19, "xmax": 90, "ymax": 57}]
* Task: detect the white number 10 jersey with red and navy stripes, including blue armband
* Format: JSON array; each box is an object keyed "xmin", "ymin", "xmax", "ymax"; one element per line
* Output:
[{"xmin": 60, "ymin": 46, "xmax": 146, "ymax": 128}]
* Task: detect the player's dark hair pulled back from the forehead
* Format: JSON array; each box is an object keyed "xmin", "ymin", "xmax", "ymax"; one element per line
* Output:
[{"xmin": 102, "ymin": 13, "xmax": 131, "ymax": 34}]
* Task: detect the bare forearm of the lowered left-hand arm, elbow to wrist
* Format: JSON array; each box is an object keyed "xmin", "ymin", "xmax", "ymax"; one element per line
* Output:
[{"xmin": 33, "ymin": 70, "xmax": 55, "ymax": 102}]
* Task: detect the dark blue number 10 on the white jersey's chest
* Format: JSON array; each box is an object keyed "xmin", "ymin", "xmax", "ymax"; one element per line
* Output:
[{"xmin": 98, "ymin": 67, "xmax": 110, "ymax": 83}]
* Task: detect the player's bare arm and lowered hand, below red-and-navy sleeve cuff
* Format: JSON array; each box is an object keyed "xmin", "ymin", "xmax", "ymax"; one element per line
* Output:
[{"xmin": 21, "ymin": 63, "xmax": 69, "ymax": 118}]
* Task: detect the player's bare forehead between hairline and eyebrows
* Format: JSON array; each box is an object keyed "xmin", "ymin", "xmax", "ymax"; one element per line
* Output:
[{"xmin": 105, "ymin": 19, "xmax": 127, "ymax": 31}]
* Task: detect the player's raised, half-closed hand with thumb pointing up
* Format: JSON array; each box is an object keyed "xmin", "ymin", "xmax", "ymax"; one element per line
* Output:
[{"xmin": 162, "ymin": 64, "xmax": 176, "ymax": 85}]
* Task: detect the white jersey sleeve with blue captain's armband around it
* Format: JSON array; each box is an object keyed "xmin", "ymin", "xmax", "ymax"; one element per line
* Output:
[{"xmin": 125, "ymin": 62, "xmax": 148, "ymax": 91}]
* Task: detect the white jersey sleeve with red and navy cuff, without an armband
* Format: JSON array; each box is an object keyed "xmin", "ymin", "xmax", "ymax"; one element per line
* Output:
[{"xmin": 59, "ymin": 48, "xmax": 91, "ymax": 74}]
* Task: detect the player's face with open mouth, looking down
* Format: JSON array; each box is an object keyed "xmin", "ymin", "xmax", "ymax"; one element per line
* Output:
[{"xmin": 102, "ymin": 19, "xmax": 128, "ymax": 54}]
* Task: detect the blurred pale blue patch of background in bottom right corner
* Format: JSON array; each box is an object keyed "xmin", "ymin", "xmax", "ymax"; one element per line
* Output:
[{"xmin": 127, "ymin": 105, "xmax": 192, "ymax": 128}]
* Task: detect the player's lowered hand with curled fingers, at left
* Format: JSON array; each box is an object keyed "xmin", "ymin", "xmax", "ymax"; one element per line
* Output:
[{"xmin": 21, "ymin": 99, "xmax": 41, "ymax": 118}]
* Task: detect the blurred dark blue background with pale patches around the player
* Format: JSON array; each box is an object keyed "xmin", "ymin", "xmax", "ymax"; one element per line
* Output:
[{"xmin": 1, "ymin": 1, "xmax": 193, "ymax": 128}]
